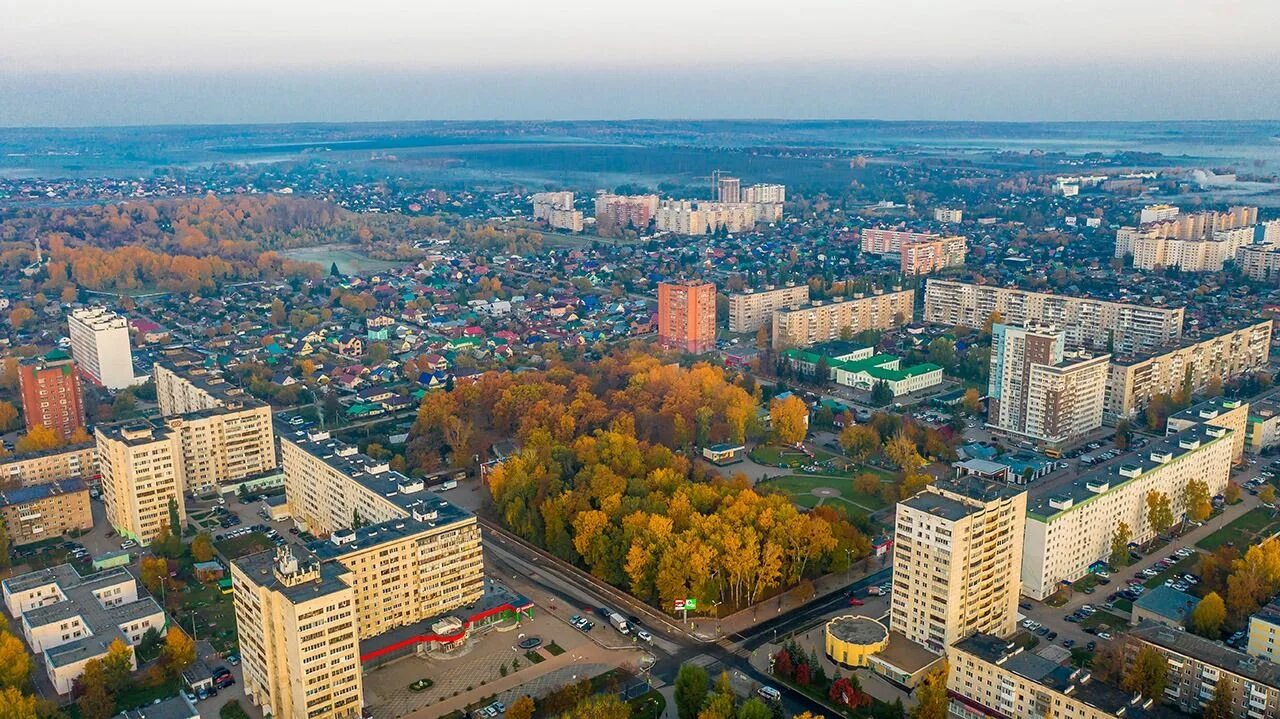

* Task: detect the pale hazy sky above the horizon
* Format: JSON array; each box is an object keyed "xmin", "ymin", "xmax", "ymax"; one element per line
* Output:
[{"xmin": 0, "ymin": 0, "xmax": 1280, "ymax": 125}]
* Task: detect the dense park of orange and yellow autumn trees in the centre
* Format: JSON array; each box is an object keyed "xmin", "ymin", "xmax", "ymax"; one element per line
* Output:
[{"xmin": 410, "ymin": 353, "xmax": 870, "ymax": 610}]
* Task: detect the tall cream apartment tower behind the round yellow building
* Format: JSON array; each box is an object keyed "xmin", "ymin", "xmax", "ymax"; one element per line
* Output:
[{"xmin": 890, "ymin": 477, "xmax": 1027, "ymax": 654}]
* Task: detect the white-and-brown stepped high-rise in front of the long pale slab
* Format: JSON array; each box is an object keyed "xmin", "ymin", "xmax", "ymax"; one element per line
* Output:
[{"xmin": 987, "ymin": 324, "xmax": 1111, "ymax": 446}]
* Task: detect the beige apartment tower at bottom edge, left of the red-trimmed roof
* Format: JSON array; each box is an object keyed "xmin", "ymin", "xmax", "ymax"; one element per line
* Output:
[{"xmin": 232, "ymin": 546, "xmax": 364, "ymax": 719}]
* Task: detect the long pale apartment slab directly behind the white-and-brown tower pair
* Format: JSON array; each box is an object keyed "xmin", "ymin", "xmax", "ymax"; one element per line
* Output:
[{"xmin": 924, "ymin": 279, "xmax": 1183, "ymax": 354}]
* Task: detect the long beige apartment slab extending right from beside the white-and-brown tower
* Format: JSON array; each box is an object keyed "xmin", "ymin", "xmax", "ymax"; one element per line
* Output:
[{"xmin": 1106, "ymin": 320, "xmax": 1271, "ymax": 421}]
